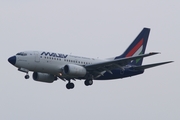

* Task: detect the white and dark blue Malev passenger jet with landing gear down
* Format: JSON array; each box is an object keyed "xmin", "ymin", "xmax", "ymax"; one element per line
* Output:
[{"xmin": 8, "ymin": 28, "xmax": 173, "ymax": 89}]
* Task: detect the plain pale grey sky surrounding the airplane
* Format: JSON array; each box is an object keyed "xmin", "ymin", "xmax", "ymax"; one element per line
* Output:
[{"xmin": 0, "ymin": 0, "xmax": 180, "ymax": 120}]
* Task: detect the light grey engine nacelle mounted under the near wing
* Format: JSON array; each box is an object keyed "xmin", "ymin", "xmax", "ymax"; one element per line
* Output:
[{"xmin": 64, "ymin": 64, "xmax": 86, "ymax": 77}]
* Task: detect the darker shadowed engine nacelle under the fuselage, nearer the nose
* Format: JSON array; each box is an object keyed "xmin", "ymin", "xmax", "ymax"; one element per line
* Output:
[{"xmin": 32, "ymin": 72, "xmax": 57, "ymax": 83}]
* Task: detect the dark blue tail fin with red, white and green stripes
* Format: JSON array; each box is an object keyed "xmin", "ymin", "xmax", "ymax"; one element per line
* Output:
[{"xmin": 115, "ymin": 28, "xmax": 150, "ymax": 65}]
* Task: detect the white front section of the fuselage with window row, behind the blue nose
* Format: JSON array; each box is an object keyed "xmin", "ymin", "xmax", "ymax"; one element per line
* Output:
[{"xmin": 15, "ymin": 51, "xmax": 106, "ymax": 74}]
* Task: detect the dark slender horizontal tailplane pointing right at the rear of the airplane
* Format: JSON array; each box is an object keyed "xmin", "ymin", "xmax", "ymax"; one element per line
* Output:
[{"xmin": 133, "ymin": 61, "xmax": 174, "ymax": 70}]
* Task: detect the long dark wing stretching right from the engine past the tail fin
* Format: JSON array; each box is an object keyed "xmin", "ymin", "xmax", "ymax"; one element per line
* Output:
[{"xmin": 85, "ymin": 52, "xmax": 158, "ymax": 77}]
